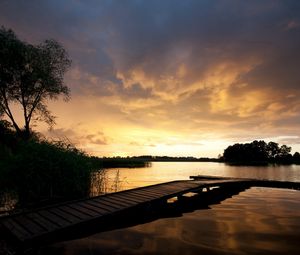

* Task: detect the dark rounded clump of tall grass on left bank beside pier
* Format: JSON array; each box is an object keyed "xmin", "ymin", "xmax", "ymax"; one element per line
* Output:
[{"xmin": 0, "ymin": 139, "xmax": 93, "ymax": 207}]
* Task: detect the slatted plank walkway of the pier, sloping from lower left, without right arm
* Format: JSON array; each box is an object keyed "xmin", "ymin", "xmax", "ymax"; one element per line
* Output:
[{"xmin": 0, "ymin": 180, "xmax": 246, "ymax": 242}]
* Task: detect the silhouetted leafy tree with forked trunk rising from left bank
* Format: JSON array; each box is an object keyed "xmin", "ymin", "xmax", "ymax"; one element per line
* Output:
[{"xmin": 0, "ymin": 27, "xmax": 71, "ymax": 137}]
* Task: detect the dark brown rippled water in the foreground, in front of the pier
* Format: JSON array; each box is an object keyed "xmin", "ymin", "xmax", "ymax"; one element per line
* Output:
[{"xmin": 41, "ymin": 188, "xmax": 300, "ymax": 255}]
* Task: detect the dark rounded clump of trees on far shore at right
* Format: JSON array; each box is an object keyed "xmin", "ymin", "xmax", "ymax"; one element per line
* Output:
[{"xmin": 221, "ymin": 140, "xmax": 300, "ymax": 165}]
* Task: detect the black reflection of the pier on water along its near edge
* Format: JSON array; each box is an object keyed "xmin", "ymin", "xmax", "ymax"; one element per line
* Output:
[{"xmin": 41, "ymin": 184, "xmax": 248, "ymax": 254}]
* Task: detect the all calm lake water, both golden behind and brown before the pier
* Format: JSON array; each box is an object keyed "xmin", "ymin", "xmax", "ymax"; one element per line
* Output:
[{"xmin": 40, "ymin": 162, "xmax": 300, "ymax": 255}]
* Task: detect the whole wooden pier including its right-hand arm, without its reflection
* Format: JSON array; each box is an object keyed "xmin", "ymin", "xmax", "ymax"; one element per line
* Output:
[{"xmin": 0, "ymin": 176, "xmax": 300, "ymax": 250}]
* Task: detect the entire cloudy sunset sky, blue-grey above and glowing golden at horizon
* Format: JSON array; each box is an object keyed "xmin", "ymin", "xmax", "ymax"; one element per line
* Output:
[{"xmin": 0, "ymin": 0, "xmax": 300, "ymax": 157}]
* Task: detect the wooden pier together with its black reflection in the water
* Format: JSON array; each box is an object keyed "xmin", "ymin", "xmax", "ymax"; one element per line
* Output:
[{"xmin": 0, "ymin": 176, "xmax": 300, "ymax": 252}]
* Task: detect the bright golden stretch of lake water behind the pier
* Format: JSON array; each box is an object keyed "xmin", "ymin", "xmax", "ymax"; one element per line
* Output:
[{"xmin": 92, "ymin": 162, "xmax": 300, "ymax": 195}]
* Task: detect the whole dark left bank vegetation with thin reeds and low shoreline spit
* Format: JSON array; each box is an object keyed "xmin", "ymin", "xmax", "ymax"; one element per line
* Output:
[{"xmin": 0, "ymin": 120, "xmax": 147, "ymax": 211}]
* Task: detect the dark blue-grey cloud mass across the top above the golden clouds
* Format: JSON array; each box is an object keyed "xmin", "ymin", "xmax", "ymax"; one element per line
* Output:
[{"xmin": 0, "ymin": 0, "xmax": 300, "ymax": 93}]
